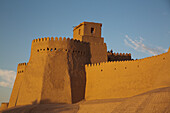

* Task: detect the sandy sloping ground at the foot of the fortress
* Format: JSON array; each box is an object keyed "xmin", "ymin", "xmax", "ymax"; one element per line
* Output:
[{"xmin": 0, "ymin": 87, "xmax": 170, "ymax": 113}]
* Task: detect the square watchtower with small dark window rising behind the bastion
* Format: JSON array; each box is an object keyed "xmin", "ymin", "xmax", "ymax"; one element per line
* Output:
[{"xmin": 73, "ymin": 22, "xmax": 107, "ymax": 63}]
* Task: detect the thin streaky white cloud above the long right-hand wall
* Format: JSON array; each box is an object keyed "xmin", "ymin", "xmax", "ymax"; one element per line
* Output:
[{"xmin": 124, "ymin": 35, "xmax": 168, "ymax": 55}]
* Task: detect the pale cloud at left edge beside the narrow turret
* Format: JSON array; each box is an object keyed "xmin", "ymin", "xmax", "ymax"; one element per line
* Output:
[{"xmin": 0, "ymin": 69, "xmax": 16, "ymax": 88}]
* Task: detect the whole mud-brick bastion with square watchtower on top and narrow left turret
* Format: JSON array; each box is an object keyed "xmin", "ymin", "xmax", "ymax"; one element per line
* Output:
[{"xmin": 9, "ymin": 22, "xmax": 107, "ymax": 107}]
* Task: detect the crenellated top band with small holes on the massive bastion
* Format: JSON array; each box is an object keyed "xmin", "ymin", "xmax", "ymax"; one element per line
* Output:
[{"xmin": 30, "ymin": 37, "xmax": 89, "ymax": 59}]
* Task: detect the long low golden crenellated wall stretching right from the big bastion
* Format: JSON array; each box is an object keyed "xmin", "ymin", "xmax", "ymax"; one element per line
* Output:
[{"xmin": 85, "ymin": 52, "xmax": 170, "ymax": 100}]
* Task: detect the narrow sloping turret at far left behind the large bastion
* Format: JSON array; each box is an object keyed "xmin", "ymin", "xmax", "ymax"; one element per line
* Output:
[{"xmin": 8, "ymin": 63, "xmax": 27, "ymax": 108}]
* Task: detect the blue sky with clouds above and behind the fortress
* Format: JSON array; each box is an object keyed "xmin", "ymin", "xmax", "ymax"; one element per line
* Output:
[{"xmin": 0, "ymin": 0, "xmax": 170, "ymax": 102}]
